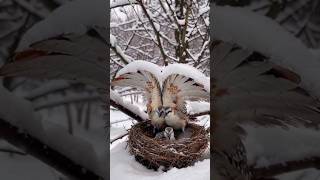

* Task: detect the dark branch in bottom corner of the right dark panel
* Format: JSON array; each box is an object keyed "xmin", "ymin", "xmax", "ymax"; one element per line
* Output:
[{"xmin": 251, "ymin": 157, "xmax": 320, "ymax": 178}]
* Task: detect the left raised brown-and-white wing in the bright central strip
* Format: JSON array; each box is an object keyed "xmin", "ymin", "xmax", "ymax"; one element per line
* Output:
[{"xmin": 111, "ymin": 71, "xmax": 162, "ymax": 113}]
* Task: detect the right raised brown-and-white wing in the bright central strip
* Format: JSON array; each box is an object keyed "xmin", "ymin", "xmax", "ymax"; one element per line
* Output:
[{"xmin": 162, "ymin": 74, "xmax": 210, "ymax": 113}]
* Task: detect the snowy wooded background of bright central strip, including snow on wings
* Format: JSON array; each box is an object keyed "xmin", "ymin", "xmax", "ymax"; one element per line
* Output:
[{"xmin": 110, "ymin": 1, "xmax": 210, "ymax": 180}]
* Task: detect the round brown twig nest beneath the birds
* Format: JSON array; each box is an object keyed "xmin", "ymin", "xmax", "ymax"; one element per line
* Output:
[{"xmin": 128, "ymin": 121, "xmax": 209, "ymax": 170}]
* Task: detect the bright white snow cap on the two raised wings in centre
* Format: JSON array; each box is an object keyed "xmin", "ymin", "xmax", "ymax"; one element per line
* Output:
[{"xmin": 117, "ymin": 60, "xmax": 210, "ymax": 92}]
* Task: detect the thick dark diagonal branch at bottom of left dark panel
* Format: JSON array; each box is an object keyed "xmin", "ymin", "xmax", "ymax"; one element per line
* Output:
[{"xmin": 0, "ymin": 119, "xmax": 103, "ymax": 180}]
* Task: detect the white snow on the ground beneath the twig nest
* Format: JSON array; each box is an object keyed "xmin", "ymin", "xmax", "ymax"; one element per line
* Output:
[{"xmin": 110, "ymin": 140, "xmax": 210, "ymax": 180}]
